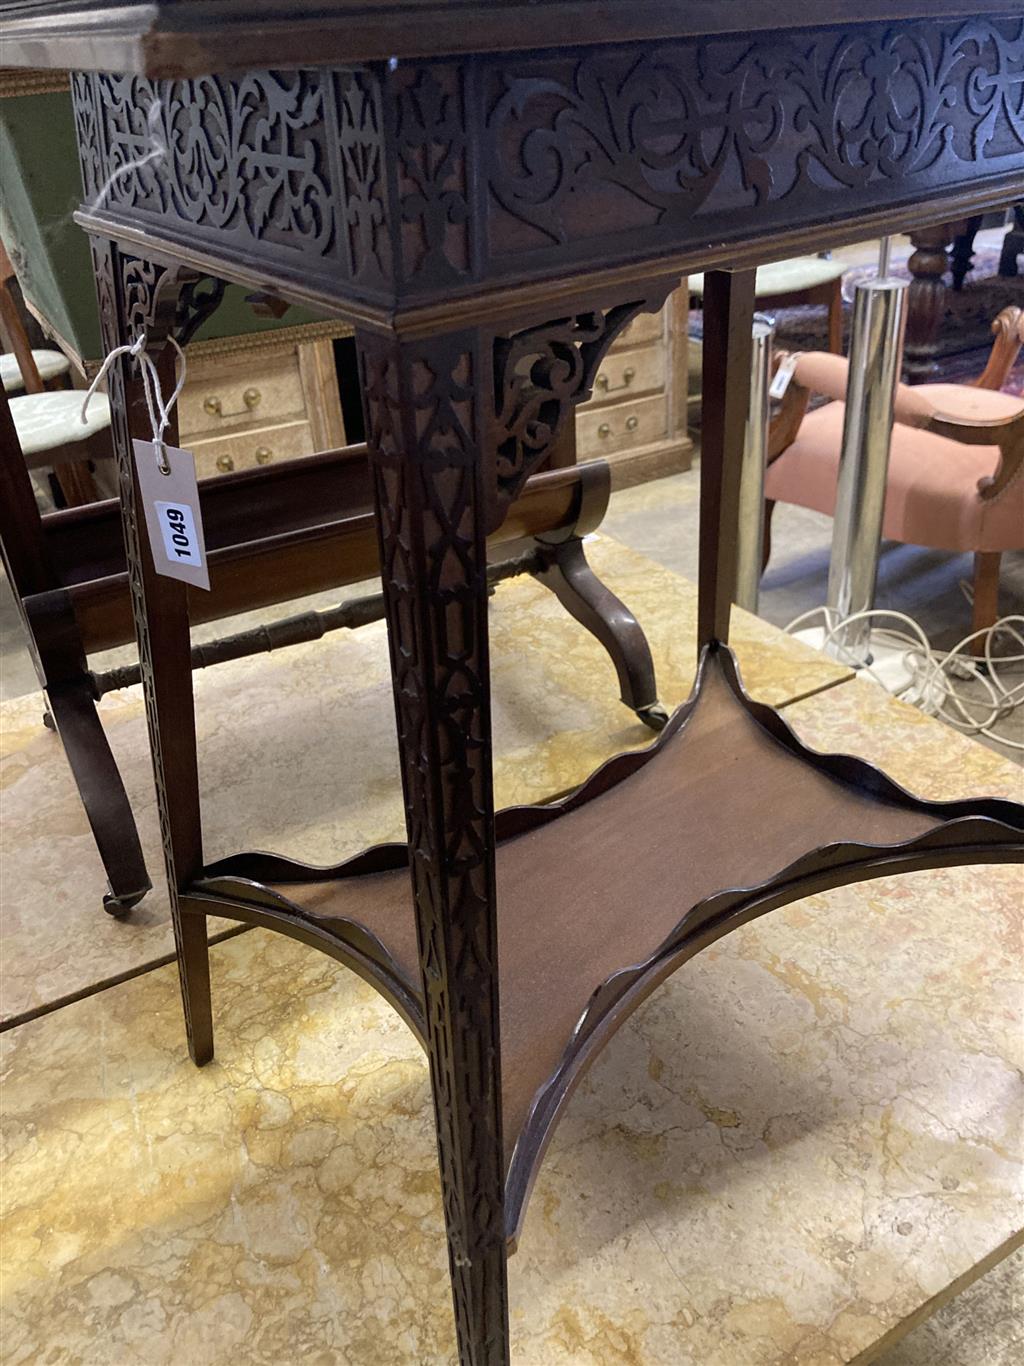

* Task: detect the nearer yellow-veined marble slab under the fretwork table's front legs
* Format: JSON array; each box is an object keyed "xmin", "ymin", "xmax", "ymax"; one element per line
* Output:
[{"xmin": 0, "ymin": 633, "xmax": 1024, "ymax": 1366}]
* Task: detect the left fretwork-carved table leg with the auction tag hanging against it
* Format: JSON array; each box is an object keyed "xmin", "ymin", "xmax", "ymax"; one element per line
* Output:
[{"xmin": 93, "ymin": 239, "xmax": 213, "ymax": 1065}]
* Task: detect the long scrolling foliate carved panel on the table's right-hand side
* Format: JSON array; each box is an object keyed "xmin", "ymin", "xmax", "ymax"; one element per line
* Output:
[{"xmin": 485, "ymin": 19, "xmax": 1024, "ymax": 257}]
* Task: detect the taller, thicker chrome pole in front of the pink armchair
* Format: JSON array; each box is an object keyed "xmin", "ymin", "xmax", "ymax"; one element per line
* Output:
[{"xmin": 827, "ymin": 254, "xmax": 907, "ymax": 665}]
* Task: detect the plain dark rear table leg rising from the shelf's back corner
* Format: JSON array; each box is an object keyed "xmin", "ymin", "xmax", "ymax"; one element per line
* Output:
[{"xmin": 696, "ymin": 270, "xmax": 755, "ymax": 656}]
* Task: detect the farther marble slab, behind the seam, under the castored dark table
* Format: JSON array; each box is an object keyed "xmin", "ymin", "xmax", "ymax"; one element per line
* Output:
[{"xmin": 0, "ymin": 537, "xmax": 849, "ymax": 1019}]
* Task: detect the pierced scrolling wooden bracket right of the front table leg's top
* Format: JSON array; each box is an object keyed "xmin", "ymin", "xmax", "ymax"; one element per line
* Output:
[{"xmin": 494, "ymin": 299, "xmax": 649, "ymax": 507}]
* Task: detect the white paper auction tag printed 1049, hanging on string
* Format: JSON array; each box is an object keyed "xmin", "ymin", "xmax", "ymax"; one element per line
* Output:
[{"xmin": 131, "ymin": 441, "xmax": 210, "ymax": 589}]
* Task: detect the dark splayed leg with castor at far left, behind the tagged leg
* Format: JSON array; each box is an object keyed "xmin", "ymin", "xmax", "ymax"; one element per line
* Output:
[{"xmin": 46, "ymin": 675, "xmax": 153, "ymax": 915}]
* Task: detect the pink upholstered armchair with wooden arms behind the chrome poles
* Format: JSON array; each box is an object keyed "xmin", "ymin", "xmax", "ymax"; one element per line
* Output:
[{"xmin": 765, "ymin": 307, "xmax": 1024, "ymax": 642}]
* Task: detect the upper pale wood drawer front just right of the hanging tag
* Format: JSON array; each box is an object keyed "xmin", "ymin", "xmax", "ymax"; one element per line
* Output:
[{"xmin": 177, "ymin": 351, "xmax": 306, "ymax": 441}]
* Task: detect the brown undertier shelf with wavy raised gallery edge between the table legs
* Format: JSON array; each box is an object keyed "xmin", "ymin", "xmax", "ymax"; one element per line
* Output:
[{"xmin": 187, "ymin": 646, "xmax": 1024, "ymax": 1242}]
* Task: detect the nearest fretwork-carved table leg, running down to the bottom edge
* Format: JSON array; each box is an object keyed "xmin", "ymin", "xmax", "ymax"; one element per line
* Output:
[{"xmin": 356, "ymin": 332, "xmax": 508, "ymax": 1366}]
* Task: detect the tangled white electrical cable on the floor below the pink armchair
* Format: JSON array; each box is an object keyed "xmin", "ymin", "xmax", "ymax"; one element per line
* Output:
[{"xmin": 786, "ymin": 607, "xmax": 1024, "ymax": 750}]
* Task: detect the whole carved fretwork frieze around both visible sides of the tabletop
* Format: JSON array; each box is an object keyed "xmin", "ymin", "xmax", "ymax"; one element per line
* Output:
[{"xmin": 72, "ymin": 18, "xmax": 1024, "ymax": 309}]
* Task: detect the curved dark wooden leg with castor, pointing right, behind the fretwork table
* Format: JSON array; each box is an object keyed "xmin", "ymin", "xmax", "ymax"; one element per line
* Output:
[{"xmin": 534, "ymin": 537, "xmax": 669, "ymax": 731}]
